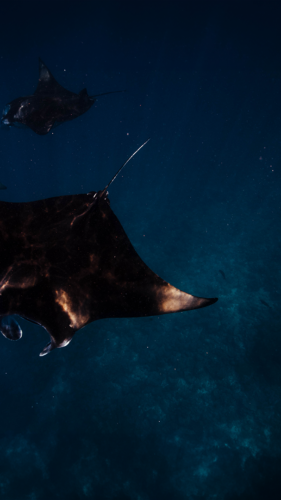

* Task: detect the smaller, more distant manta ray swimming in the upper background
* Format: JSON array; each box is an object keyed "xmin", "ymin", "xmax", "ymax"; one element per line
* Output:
[{"xmin": 1, "ymin": 58, "xmax": 123, "ymax": 135}]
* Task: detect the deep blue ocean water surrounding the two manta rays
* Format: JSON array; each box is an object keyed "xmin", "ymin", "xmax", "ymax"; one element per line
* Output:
[{"xmin": 0, "ymin": 0, "xmax": 281, "ymax": 500}]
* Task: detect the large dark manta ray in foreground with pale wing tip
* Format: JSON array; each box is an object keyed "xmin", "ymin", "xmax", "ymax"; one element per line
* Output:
[{"xmin": 0, "ymin": 141, "xmax": 218, "ymax": 356}]
